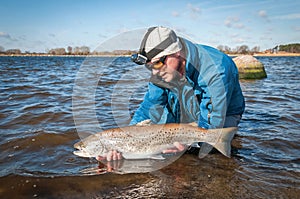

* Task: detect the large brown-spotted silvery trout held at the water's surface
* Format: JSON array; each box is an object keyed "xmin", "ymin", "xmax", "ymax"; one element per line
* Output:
[{"xmin": 73, "ymin": 123, "xmax": 237, "ymax": 160}]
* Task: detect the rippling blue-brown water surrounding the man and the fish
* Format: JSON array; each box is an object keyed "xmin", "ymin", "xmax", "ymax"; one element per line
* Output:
[{"xmin": 0, "ymin": 57, "xmax": 300, "ymax": 198}]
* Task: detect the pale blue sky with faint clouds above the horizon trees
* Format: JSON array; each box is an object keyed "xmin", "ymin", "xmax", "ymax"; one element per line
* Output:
[{"xmin": 0, "ymin": 0, "xmax": 300, "ymax": 52}]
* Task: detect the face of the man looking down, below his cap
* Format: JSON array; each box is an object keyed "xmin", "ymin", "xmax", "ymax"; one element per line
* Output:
[{"xmin": 151, "ymin": 54, "xmax": 181, "ymax": 82}]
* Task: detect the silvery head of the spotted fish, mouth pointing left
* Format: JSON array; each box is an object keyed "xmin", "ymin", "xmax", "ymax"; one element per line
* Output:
[{"xmin": 73, "ymin": 135, "xmax": 107, "ymax": 157}]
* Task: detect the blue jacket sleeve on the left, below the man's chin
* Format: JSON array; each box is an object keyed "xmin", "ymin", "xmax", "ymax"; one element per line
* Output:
[{"xmin": 130, "ymin": 82, "xmax": 167, "ymax": 125}]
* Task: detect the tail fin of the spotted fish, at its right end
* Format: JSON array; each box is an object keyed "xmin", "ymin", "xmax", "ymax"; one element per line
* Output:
[{"xmin": 206, "ymin": 127, "xmax": 238, "ymax": 158}]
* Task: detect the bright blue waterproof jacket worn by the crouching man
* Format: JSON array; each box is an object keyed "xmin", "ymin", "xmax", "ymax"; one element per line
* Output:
[{"xmin": 130, "ymin": 38, "xmax": 245, "ymax": 128}]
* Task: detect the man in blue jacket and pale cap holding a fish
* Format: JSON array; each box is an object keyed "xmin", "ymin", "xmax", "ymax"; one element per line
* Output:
[{"xmin": 99, "ymin": 27, "xmax": 245, "ymax": 160}]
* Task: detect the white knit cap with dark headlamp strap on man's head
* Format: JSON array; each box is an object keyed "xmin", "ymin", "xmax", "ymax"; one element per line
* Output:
[{"xmin": 140, "ymin": 26, "xmax": 182, "ymax": 60}]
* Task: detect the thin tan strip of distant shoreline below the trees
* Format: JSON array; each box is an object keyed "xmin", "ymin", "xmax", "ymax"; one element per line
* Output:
[{"xmin": 0, "ymin": 53, "xmax": 300, "ymax": 57}]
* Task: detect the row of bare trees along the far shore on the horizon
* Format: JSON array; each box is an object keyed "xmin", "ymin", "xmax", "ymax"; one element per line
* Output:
[{"xmin": 0, "ymin": 43, "xmax": 300, "ymax": 55}]
